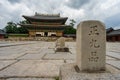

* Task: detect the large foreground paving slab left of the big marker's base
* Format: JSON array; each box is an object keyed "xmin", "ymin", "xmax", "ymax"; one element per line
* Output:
[{"xmin": 0, "ymin": 60, "xmax": 64, "ymax": 78}]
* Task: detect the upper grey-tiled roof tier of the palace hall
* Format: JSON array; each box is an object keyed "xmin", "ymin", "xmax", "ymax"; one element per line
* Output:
[{"xmin": 23, "ymin": 13, "xmax": 68, "ymax": 24}]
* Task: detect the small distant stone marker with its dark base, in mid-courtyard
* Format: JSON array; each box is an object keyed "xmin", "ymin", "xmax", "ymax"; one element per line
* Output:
[{"xmin": 55, "ymin": 37, "xmax": 69, "ymax": 52}]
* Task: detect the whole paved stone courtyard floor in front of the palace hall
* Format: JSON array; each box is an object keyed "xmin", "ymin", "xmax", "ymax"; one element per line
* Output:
[{"xmin": 0, "ymin": 41, "xmax": 120, "ymax": 80}]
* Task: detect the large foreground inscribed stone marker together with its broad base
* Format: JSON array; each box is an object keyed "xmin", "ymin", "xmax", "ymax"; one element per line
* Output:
[{"xmin": 60, "ymin": 20, "xmax": 120, "ymax": 80}]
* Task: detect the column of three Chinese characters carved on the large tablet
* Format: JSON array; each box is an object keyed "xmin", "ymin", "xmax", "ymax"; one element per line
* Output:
[{"xmin": 88, "ymin": 25, "xmax": 100, "ymax": 62}]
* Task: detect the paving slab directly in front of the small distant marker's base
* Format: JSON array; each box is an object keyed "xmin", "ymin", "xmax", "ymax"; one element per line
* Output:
[{"xmin": 43, "ymin": 52, "xmax": 75, "ymax": 60}]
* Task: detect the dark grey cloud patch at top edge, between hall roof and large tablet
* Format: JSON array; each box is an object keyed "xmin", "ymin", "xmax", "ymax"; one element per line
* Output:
[{"xmin": 66, "ymin": 0, "xmax": 90, "ymax": 9}]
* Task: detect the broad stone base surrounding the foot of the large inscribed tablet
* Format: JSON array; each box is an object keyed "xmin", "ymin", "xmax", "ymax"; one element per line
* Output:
[{"xmin": 60, "ymin": 64, "xmax": 120, "ymax": 80}]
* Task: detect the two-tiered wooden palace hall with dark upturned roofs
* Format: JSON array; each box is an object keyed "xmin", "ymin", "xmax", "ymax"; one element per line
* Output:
[{"xmin": 20, "ymin": 13, "xmax": 69, "ymax": 37}]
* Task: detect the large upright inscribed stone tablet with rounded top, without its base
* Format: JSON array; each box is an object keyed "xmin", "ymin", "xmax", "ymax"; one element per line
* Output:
[{"xmin": 76, "ymin": 20, "xmax": 106, "ymax": 71}]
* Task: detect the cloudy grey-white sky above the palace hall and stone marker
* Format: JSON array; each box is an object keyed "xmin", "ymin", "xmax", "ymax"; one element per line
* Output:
[{"xmin": 0, "ymin": 0, "xmax": 120, "ymax": 29}]
